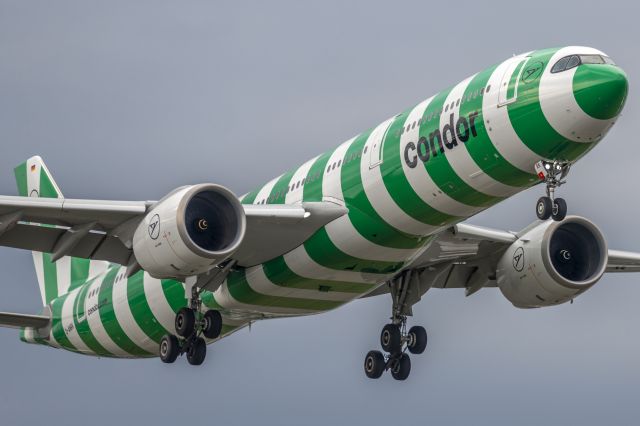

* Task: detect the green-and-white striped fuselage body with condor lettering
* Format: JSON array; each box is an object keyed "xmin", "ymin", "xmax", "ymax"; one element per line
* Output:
[{"xmin": 22, "ymin": 47, "xmax": 628, "ymax": 357}]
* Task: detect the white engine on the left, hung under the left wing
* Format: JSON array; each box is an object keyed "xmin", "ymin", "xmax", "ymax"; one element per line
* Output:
[{"xmin": 133, "ymin": 184, "xmax": 246, "ymax": 279}]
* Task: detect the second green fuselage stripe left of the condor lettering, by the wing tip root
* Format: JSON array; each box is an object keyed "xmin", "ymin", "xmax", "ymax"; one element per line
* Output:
[{"xmin": 342, "ymin": 130, "xmax": 424, "ymax": 249}]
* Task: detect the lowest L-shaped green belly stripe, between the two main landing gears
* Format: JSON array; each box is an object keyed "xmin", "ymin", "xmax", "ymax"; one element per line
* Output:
[{"xmin": 227, "ymin": 266, "xmax": 342, "ymax": 311}]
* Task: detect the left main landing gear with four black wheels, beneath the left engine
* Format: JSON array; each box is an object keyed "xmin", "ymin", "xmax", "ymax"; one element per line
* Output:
[{"xmin": 159, "ymin": 287, "xmax": 222, "ymax": 365}]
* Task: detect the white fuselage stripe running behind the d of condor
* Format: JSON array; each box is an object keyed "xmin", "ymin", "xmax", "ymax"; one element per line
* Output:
[{"xmin": 440, "ymin": 76, "xmax": 521, "ymax": 197}]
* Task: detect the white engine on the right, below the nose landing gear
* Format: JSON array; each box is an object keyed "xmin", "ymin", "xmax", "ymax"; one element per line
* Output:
[{"xmin": 496, "ymin": 216, "xmax": 607, "ymax": 308}]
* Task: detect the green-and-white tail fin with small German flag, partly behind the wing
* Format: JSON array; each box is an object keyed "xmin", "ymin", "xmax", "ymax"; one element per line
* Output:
[{"xmin": 14, "ymin": 156, "xmax": 108, "ymax": 306}]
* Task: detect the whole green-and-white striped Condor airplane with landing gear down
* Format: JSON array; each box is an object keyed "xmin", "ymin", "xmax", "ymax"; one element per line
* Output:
[{"xmin": 0, "ymin": 46, "xmax": 640, "ymax": 380}]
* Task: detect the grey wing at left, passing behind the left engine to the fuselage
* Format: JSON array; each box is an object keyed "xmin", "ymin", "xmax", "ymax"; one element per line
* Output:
[{"xmin": 0, "ymin": 196, "xmax": 346, "ymax": 266}]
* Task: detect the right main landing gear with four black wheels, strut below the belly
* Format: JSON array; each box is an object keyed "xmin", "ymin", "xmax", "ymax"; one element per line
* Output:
[{"xmin": 364, "ymin": 271, "xmax": 427, "ymax": 380}]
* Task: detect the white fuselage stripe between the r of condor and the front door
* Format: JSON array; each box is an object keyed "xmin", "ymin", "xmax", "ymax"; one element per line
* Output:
[{"xmin": 482, "ymin": 55, "xmax": 540, "ymax": 172}]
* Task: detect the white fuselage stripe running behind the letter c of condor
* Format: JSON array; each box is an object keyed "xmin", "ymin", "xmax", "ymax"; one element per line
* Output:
[{"xmin": 400, "ymin": 97, "xmax": 481, "ymax": 217}]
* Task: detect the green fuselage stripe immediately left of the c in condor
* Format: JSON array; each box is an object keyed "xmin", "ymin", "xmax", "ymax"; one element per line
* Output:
[{"xmin": 380, "ymin": 111, "xmax": 457, "ymax": 226}]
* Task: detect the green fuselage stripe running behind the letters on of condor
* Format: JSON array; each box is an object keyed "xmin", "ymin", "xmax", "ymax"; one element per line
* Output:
[{"xmin": 420, "ymin": 89, "xmax": 502, "ymax": 207}]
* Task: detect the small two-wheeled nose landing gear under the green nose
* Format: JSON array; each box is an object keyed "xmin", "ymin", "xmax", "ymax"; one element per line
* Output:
[{"xmin": 535, "ymin": 161, "xmax": 571, "ymax": 221}]
